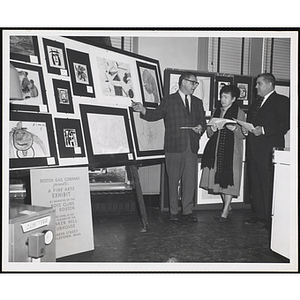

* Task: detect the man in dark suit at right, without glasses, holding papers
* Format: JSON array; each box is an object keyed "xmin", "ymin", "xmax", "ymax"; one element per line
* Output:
[{"xmin": 244, "ymin": 73, "xmax": 290, "ymax": 230}]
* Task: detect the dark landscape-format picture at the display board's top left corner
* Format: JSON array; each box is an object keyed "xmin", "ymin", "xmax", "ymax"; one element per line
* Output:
[{"xmin": 9, "ymin": 35, "xmax": 41, "ymax": 64}]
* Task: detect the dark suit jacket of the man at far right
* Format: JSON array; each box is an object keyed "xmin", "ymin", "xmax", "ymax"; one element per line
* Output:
[{"xmin": 247, "ymin": 92, "xmax": 290, "ymax": 161}]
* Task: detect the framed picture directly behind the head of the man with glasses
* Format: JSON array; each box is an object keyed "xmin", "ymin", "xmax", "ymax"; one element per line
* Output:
[{"xmin": 164, "ymin": 69, "xmax": 215, "ymax": 117}]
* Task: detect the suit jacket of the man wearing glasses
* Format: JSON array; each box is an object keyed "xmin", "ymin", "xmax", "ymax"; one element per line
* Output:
[{"xmin": 141, "ymin": 92, "xmax": 206, "ymax": 153}]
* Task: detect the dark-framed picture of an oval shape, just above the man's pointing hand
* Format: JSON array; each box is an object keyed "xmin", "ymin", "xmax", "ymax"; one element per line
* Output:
[{"xmin": 136, "ymin": 61, "xmax": 162, "ymax": 107}]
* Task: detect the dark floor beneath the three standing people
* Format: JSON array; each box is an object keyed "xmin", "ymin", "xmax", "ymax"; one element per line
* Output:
[{"xmin": 57, "ymin": 208, "xmax": 288, "ymax": 264}]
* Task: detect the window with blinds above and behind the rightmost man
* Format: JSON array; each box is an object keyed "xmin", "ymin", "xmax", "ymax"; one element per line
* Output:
[{"xmin": 262, "ymin": 38, "xmax": 291, "ymax": 80}]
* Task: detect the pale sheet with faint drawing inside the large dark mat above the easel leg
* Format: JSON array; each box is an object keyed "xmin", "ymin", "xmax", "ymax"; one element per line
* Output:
[{"xmin": 87, "ymin": 113, "xmax": 130, "ymax": 155}]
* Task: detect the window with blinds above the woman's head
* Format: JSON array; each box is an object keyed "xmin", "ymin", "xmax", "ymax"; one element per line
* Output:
[{"xmin": 208, "ymin": 37, "xmax": 251, "ymax": 75}]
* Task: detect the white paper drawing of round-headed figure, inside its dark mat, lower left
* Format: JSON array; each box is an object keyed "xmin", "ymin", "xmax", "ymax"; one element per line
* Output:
[{"xmin": 9, "ymin": 121, "xmax": 50, "ymax": 158}]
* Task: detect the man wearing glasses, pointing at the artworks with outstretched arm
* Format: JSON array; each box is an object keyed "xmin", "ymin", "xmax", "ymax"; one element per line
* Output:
[{"xmin": 132, "ymin": 72, "xmax": 206, "ymax": 222}]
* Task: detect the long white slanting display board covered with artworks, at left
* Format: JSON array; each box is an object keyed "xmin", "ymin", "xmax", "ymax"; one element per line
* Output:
[{"xmin": 7, "ymin": 30, "xmax": 164, "ymax": 169}]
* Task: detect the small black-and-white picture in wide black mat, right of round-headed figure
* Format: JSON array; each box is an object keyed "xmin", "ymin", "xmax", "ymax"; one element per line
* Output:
[{"xmin": 54, "ymin": 118, "xmax": 85, "ymax": 158}]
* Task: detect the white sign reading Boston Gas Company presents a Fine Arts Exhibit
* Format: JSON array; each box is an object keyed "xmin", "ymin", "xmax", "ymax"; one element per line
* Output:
[{"xmin": 30, "ymin": 167, "xmax": 94, "ymax": 258}]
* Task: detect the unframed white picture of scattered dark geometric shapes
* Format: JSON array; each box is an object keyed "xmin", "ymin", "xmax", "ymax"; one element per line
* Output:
[{"xmin": 97, "ymin": 57, "xmax": 134, "ymax": 98}]
